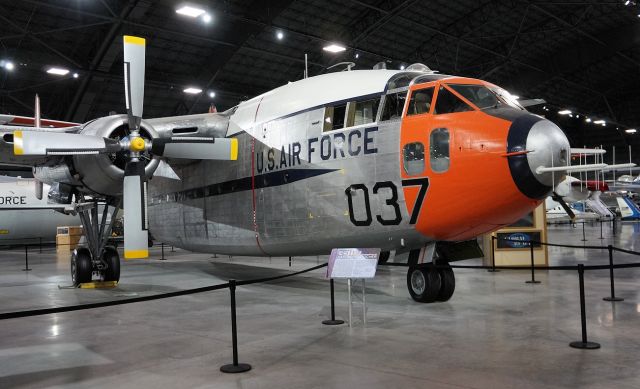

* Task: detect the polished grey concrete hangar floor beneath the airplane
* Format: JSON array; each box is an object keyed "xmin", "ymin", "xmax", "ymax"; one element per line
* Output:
[{"xmin": 0, "ymin": 224, "xmax": 640, "ymax": 389}]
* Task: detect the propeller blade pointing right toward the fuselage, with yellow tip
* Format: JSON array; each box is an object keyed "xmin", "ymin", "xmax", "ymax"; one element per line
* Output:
[{"xmin": 151, "ymin": 137, "xmax": 238, "ymax": 161}]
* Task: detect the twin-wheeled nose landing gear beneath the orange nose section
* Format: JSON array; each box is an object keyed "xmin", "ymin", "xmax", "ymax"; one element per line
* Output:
[{"xmin": 407, "ymin": 245, "xmax": 456, "ymax": 303}]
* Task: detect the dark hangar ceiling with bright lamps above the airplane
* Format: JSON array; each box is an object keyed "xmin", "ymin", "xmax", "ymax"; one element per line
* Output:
[{"xmin": 0, "ymin": 0, "xmax": 640, "ymax": 163}]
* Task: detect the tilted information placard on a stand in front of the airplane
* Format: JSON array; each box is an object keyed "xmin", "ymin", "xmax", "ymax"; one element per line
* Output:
[{"xmin": 327, "ymin": 248, "xmax": 380, "ymax": 278}]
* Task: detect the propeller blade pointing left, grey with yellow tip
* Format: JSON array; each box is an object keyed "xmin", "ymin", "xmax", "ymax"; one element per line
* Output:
[{"xmin": 13, "ymin": 131, "xmax": 121, "ymax": 156}]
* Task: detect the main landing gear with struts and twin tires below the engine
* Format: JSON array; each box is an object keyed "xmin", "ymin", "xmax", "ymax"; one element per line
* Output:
[{"xmin": 71, "ymin": 202, "xmax": 120, "ymax": 286}]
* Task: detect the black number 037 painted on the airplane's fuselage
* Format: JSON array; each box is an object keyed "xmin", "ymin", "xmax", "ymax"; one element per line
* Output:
[{"xmin": 344, "ymin": 177, "xmax": 429, "ymax": 227}]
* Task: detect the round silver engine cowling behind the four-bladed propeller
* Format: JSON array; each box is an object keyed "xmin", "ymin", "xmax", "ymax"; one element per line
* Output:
[{"xmin": 71, "ymin": 115, "xmax": 160, "ymax": 196}]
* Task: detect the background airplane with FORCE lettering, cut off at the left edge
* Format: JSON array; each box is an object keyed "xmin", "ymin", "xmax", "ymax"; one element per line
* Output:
[{"xmin": 0, "ymin": 176, "xmax": 80, "ymax": 245}]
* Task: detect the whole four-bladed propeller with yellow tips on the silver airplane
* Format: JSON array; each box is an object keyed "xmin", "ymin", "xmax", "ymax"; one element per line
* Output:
[{"xmin": 13, "ymin": 35, "xmax": 238, "ymax": 259}]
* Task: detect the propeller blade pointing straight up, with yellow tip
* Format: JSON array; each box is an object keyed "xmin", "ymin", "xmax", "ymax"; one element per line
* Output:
[{"xmin": 123, "ymin": 35, "xmax": 146, "ymax": 120}]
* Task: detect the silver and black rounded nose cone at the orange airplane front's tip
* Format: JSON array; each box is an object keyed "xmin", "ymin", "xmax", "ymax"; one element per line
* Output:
[{"xmin": 507, "ymin": 114, "xmax": 570, "ymax": 200}]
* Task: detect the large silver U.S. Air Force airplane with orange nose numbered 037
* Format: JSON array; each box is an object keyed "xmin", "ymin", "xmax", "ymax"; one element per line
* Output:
[{"xmin": 0, "ymin": 36, "xmax": 624, "ymax": 302}]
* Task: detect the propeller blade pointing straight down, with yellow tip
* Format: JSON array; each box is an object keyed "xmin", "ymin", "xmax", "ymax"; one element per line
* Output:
[{"xmin": 122, "ymin": 161, "xmax": 149, "ymax": 259}]
